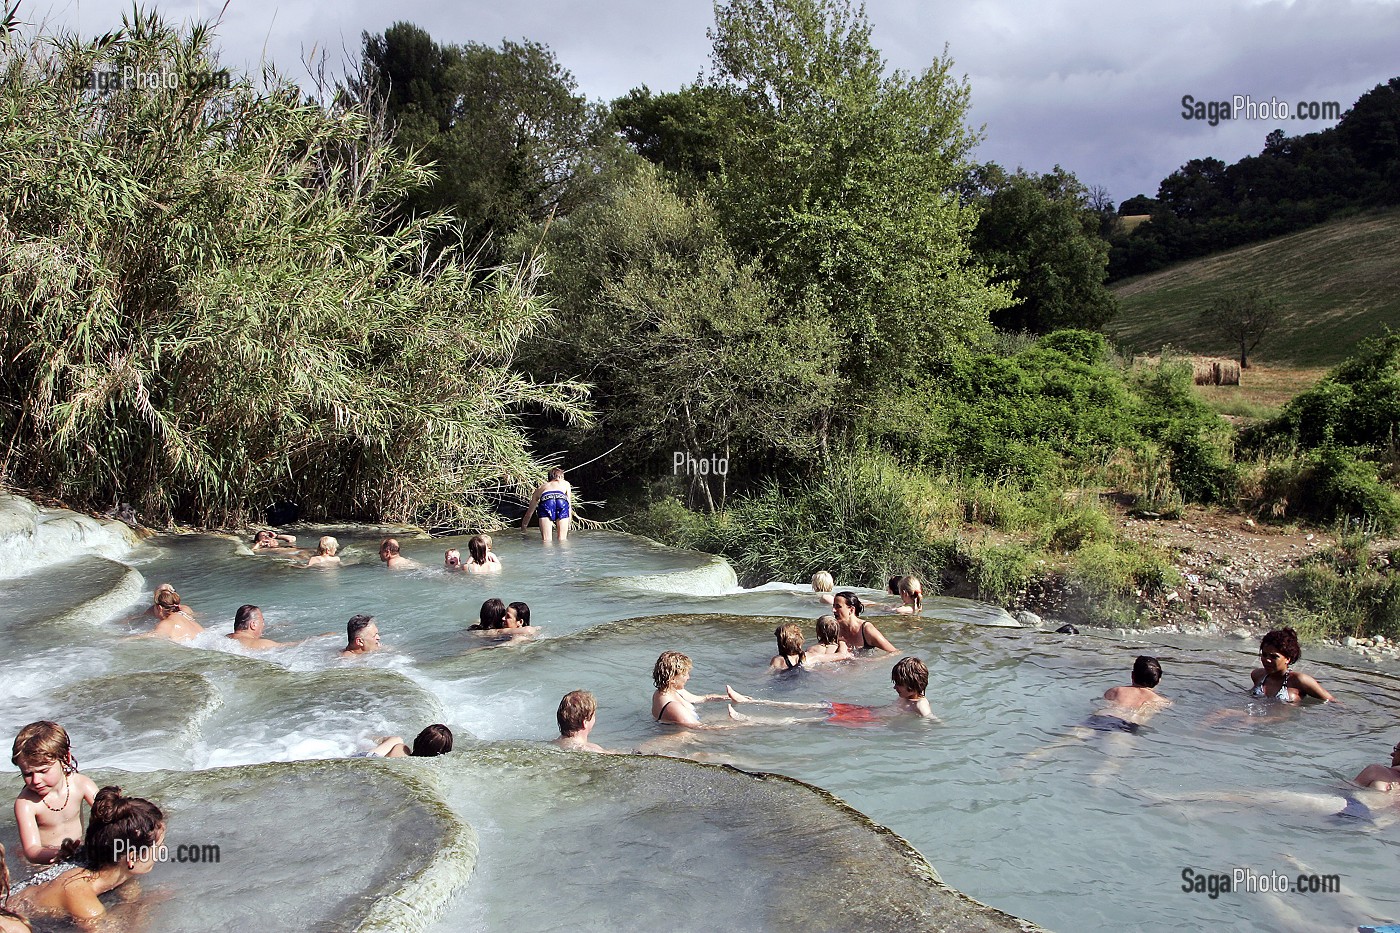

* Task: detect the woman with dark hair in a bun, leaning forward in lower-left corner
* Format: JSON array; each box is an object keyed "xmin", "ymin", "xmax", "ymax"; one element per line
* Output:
[{"xmin": 7, "ymin": 787, "xmax": 165, "ymax": 920}]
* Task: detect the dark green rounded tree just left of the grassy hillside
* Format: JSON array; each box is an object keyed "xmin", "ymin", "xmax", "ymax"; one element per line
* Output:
[{"xmin": 973, "ymin": 163, "xmax": 1117, "ymax": 333}]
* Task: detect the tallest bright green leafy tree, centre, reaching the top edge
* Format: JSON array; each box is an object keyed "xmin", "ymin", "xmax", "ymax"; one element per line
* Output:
[{"xmin": 710, "ymin": 0, "xmax": 1011, "ymax": 422}]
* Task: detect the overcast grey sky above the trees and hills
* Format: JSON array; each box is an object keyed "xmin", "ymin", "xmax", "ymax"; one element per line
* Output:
[{"xmin": 30, "ymin": 0, "xmax": 1400, "ymax": 202}]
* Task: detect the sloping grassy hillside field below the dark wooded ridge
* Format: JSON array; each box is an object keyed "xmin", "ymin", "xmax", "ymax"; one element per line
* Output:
[{"xmin": 1107, "ymin": 210, "xmax": 1400, "ymax": 367}]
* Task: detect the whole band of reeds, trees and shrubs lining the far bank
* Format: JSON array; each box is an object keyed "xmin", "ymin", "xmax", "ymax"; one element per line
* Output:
[{"xmin": 0, "ymin": 0, "xmax": 1400, "ymax": 630}]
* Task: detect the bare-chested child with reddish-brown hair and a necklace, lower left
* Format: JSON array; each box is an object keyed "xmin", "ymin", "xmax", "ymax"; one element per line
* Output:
[{"xmin": 10, "ymin": 720, "xmax": 97, "ymax": 864}]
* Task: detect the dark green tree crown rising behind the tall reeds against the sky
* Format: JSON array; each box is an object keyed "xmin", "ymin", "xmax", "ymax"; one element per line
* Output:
[{"xmin": 363, "ymin": 22, "xmax": 610, "ymax": 263}]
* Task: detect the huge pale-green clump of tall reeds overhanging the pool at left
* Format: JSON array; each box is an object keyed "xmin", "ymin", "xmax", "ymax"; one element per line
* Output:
[{"xmin": 0, "ymin": 13, "xmax": 584, "ymax": 525}]
